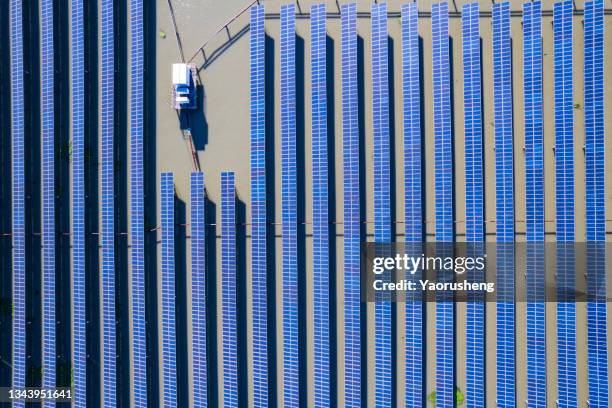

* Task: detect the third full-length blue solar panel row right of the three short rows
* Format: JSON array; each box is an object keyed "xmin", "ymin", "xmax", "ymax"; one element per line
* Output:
[{"xmin": 310, "ymin": 4, "xmax": 331, "ymax": 407}]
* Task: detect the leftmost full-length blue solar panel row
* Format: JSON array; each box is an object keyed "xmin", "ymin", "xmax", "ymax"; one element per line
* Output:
[{"xmin": 10, "ymin": 0, "xmax": 26, "ymax": 407}]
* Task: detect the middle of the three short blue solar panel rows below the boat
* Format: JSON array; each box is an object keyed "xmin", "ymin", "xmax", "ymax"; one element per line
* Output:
[{"xmin": 190, "ymin": 172, "xmax": 208, "ymax": 407}]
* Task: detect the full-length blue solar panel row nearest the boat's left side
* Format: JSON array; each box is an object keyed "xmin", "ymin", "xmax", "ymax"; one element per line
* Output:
[{"xmin": 130, "ymin": 0, "xmax": 147, "ymax": 407}]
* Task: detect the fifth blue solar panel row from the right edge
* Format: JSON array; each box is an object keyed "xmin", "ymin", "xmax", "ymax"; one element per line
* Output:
[{"xmin": 461, "ymin": 2, "xmax": 485, "ymax": 407}]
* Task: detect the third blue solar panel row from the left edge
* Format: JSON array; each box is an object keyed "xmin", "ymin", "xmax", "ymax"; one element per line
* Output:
[{"xmin": 71, "ymin": 0, "xmax": 87, "ymax": 408}]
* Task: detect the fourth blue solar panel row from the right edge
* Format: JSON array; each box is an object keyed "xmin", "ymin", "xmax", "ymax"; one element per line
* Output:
[{"xmin": 493, "ymin": 2, "xmax": 516, "ymax": 406}]
